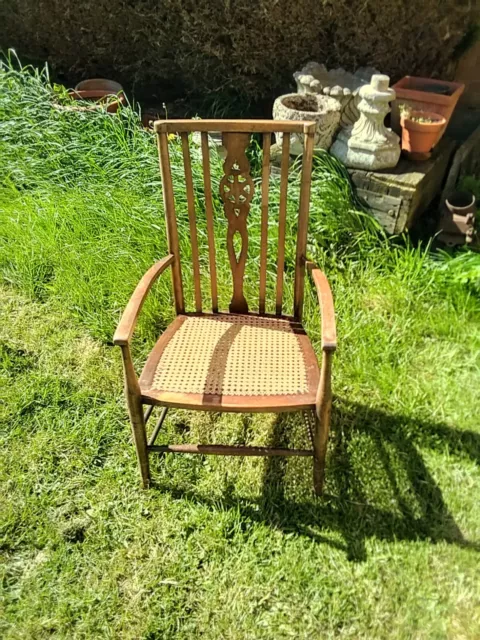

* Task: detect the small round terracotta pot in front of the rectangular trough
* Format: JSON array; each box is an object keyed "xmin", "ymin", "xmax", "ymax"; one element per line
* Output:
[{"xmin": 399, "ymin": 105, "xmax": 446, "ymax": 160}]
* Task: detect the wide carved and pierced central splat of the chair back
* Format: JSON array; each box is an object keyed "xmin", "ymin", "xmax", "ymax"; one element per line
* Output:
[{"xmin": 220, "ymin": 133, "xmax": 253, "ymax": 313}]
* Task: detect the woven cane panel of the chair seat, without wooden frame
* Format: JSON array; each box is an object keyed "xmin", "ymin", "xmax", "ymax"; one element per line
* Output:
[{"xmin": 146, "ymin": 314, "xmax": 309, "ymax": 396}]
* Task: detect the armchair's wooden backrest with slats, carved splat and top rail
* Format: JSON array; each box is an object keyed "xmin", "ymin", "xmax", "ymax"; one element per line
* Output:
[{"xmin": 155, "ymin": 120, "xmax": 315, "ymax": 320}]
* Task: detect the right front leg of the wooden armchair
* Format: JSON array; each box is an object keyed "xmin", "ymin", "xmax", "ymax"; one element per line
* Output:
[{"xmin": 313, "ymin": 350, "xmax": 334, "ymax": 495}]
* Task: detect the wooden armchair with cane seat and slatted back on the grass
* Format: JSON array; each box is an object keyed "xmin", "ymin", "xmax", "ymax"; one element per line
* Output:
[{"xmin": 114, "ymin": 120, "xmax": 336, "ymax": 494}]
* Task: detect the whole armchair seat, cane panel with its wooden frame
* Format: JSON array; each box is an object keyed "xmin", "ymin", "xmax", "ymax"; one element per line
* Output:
[{"xmin": 140, "ymin": 314, "xmax": 319, "ymax": 411}]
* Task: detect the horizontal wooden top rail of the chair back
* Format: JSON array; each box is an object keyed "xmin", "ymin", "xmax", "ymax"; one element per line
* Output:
[{"xmin": 154, "ymin": 119, "xmax": 315, "ymax": 133}]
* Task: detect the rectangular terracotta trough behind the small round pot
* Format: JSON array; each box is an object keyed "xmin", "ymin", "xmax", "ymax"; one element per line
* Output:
[{"xmin": 392, "ymin": 76, "xmax": 465, "ymax": 142}]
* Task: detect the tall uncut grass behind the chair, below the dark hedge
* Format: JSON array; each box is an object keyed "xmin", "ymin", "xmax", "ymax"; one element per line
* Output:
[{"xmin": 0, "ymin": 55, "xmax": 382, "ymax": 340}]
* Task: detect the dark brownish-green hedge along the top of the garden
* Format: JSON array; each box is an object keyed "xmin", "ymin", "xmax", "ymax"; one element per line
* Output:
[{"xmin": 0, "ymin": 0, "xmax": 478, "ymax": 104}]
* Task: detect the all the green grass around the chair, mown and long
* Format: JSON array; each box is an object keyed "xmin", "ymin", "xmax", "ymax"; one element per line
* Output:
[{"xmin": 0, "ymin": 56, "xmax": 480, "ymax": 640}]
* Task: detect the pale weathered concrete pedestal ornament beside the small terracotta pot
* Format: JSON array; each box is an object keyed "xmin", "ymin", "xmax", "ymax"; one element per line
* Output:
[{"xmin": 330, "ymin": 74, "xmax": 400, "ymax": 170}]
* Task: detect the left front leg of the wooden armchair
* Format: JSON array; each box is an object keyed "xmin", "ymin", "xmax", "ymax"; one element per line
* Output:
[{"xmin": 121, "ymin": 344, "xmax": 150, "ymax": 489}]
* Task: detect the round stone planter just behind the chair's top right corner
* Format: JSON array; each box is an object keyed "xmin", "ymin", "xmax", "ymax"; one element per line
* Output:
[{"xmin": 273, "ymin": 93, "xmax": 342, "ymax": 155}]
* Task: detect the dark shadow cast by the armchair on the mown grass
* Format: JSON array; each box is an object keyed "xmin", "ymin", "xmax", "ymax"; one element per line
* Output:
[{"xmin": 156, "ymin": 399, "xmax": 480, "ymax": 561}]
